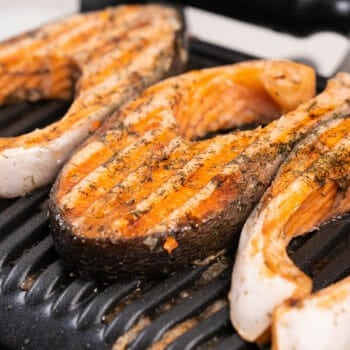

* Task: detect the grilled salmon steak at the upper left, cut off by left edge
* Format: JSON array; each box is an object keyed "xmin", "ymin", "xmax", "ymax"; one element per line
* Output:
[{"xmin": 0, "ymin": 5, "xmax": 186, "ymax": 197}]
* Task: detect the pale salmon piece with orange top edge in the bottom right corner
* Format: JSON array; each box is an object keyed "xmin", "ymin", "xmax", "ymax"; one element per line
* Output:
[{"xmin": 272, "ymin": 277, "xmax": 350, "ymax": 350}]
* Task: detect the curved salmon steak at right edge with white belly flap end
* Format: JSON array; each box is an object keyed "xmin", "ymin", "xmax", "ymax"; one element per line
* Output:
[{"xmin": 229, "ymin": 73, "xmax": 350, "ymax": 342}]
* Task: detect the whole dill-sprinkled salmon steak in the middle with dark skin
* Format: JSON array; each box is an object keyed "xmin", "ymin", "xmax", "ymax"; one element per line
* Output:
[{"xmin": 50, "ymin": 61, "xmax": 318, "ymax": 279}]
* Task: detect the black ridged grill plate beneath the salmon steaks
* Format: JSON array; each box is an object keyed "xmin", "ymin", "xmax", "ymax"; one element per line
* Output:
[{"xmin": 0, "ymin": 3, "xmax": 350, "ymax": 350}]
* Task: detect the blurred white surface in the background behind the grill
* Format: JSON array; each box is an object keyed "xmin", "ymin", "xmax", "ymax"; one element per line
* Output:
[{"xmin": 0, "ymin": 0, "xmax": 349, "ymax": 77}]
